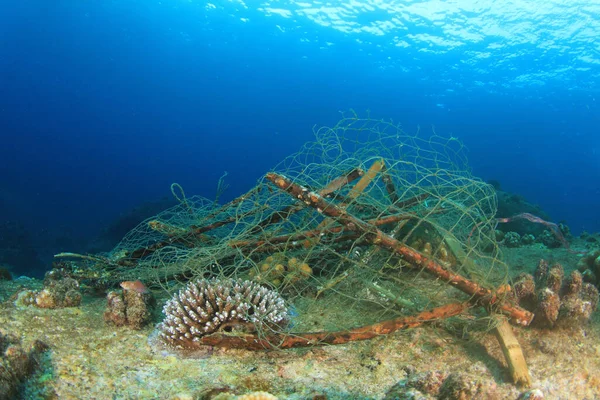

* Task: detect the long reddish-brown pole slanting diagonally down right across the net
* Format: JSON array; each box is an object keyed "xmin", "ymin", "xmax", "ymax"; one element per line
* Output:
[{"xmin": 267, "ymin": 173, "xmax": 533, "ymax": 326}]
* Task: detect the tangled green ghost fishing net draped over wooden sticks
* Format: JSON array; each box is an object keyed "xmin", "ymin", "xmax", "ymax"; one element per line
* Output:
[{"xmin": 57, "ymin": 115, "xmax": 531, "ymax": 354}]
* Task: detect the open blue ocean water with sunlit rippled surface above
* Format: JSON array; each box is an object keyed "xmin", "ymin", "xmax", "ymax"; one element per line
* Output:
[{"xmin": 0, "ymin": 0, "xmax": 600, "ymax": 276}]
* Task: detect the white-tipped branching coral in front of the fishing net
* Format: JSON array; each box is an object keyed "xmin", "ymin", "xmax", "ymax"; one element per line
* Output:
[{"xmin": 158, "ymin": 279, "xmax": 289, "ymax": 349}]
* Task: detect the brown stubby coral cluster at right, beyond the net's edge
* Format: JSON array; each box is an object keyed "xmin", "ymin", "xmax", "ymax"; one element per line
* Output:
[{"xmin": 513, "ymin": 260, "xmax": 598, "ymax": 327}]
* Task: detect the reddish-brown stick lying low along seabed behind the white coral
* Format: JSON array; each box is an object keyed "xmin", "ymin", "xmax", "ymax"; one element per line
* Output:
[{"xmin": 197, "ymin": 303, "xmax": 469, "ymax": 350}]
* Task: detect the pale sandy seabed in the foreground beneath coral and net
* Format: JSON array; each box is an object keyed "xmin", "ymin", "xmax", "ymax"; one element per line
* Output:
[{"xmin": 0, "ymin": 242, "xmax": 600, "ymax": 399}]
